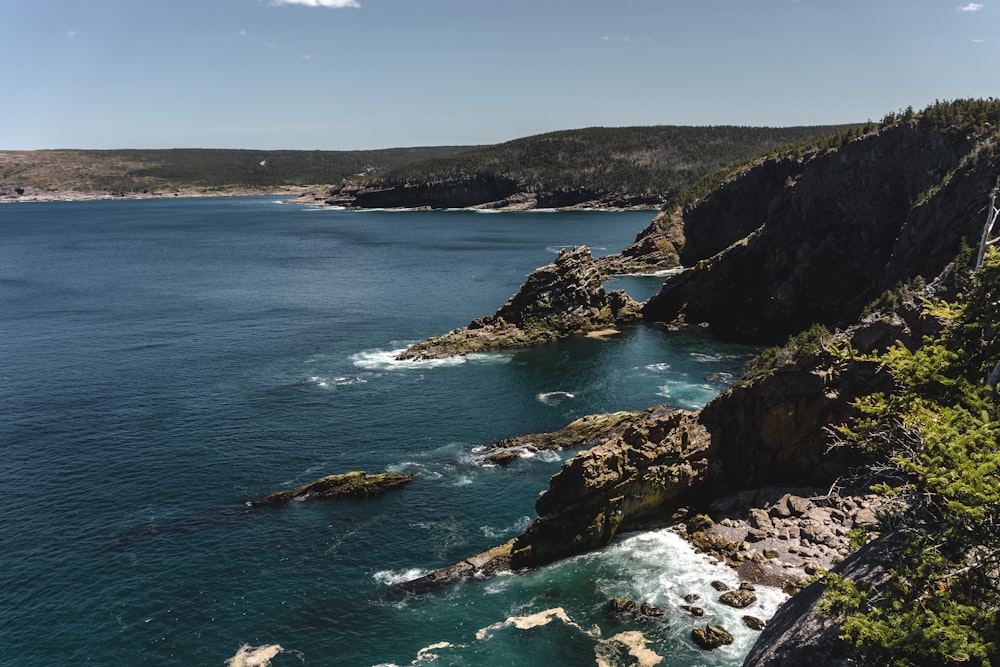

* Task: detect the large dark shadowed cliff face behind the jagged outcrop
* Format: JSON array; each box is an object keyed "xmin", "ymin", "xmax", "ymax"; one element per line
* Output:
[{"xmin": 604, "ymin": 124, "xmax": 997, "ymax": 343}]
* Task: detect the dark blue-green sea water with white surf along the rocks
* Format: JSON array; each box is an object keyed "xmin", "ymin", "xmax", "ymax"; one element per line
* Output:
[{"xmin": 0, "ymin": 198, "xmax": 780, "ymax": 667}]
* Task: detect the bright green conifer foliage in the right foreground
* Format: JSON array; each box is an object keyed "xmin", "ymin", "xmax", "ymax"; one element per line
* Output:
[{"xmin": 826, "ymin": 252, "xmax": 1000, "ymax": 666}]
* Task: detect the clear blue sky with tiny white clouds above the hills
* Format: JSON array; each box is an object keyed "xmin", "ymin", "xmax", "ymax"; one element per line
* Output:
[{"xmin": 0, "ymin": 0, "xmax": 1000, "ymax": 150}]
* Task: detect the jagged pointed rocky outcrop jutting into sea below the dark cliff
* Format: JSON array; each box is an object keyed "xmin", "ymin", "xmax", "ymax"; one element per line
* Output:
[{"xmin": 398, "ymin": 246, "xmax": 639, "ymax": 360}]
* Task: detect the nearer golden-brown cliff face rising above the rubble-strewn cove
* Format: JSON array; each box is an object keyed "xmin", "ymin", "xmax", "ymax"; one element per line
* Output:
[{"xmin": 511, "ymin": 318, "xmax": 910, "ymax": 567}]
